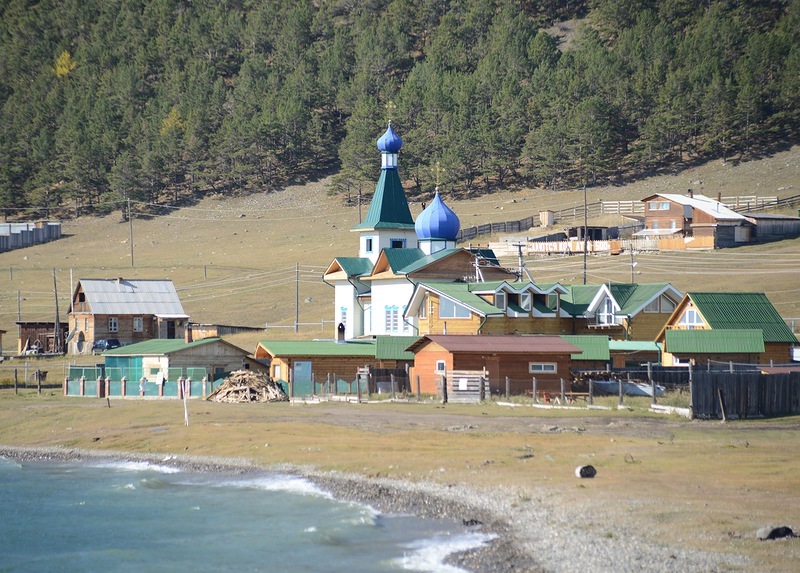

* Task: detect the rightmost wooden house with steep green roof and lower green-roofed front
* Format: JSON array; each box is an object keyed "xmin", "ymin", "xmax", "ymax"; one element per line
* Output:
[{"xmin": 656, "ymin": 292, "xmax": 798, "ymax": 366}]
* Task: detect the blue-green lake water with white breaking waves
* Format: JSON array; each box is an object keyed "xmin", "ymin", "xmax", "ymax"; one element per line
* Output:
[{"xmin": 0, "ymin": 458, "xmax": 489, "ymax": 573}]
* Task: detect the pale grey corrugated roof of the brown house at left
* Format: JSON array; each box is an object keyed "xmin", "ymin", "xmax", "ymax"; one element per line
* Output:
[{"xmin": 79, "ymin": 279, "xmax": 189, "ymax": 318}]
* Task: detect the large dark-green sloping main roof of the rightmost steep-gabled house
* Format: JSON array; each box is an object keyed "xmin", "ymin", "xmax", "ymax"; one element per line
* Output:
[{"xmin": 687, "ymin": 292, "xmax": 798, "ymax": 344}]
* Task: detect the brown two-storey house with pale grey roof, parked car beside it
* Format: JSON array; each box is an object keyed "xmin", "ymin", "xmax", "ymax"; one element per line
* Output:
[{"xmin": 68, "ymin": 278, "xmax": 189, "ymax": 354}]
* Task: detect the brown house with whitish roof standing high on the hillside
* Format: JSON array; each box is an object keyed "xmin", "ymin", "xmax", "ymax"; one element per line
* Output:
[{"xmin": 635, "ymin": 189, "xmax": 753, "ymax": 248}]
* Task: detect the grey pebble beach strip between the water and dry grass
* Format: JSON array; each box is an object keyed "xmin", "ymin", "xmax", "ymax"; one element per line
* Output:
[{"xmin": 0, "ymin": 445, "xmax": 748, "ymax": 573}]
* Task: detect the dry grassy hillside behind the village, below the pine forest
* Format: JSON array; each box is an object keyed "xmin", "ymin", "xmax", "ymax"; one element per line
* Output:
[{"xmin": 0, "ymin": 147, "xmax": 800, "ymax": 354}]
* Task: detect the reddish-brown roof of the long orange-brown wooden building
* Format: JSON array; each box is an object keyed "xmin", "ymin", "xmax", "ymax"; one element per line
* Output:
[{"xmin": 409, "ymin": 334, "xmax": 583, "ymax": 354}]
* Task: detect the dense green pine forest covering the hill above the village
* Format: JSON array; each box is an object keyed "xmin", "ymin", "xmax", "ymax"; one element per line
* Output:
[{"xmin": 0, "ymin": 0, "xmax": 800, "ymax": 218}]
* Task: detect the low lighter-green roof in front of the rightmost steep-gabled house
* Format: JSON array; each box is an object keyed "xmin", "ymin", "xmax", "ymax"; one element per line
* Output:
[{"xmin": 665, "ymin": 329, "xmax": 764, "ymax": 354}]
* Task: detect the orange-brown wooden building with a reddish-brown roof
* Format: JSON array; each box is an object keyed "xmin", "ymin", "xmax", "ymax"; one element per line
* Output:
[{"xmin": 409, "ymin": 334, "xmax": 582, "ymax": 394}]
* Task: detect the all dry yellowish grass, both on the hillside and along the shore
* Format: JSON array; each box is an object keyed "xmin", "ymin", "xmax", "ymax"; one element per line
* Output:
[{"xmin": 0, "ymin": 147, "xmax": 800, "ymax": 572}]
